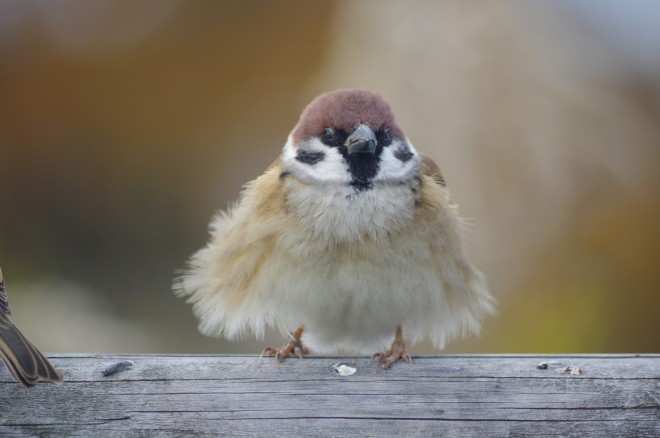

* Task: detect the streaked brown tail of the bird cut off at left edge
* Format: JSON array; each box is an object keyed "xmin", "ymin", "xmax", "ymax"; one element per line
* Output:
[{"xmin": 0, "ymin": 270, "xmax": 62, "ymax": 387}]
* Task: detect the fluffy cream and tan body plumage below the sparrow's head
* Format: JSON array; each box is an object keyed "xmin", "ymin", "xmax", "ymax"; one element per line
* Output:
[{"xmin": 179, "ymin": 162, "xmax": 492, "ymax": 352}]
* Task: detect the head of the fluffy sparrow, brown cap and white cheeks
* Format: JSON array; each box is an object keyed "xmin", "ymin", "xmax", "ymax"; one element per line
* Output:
[{"xmin": 282, "ymin": 90, "xmax": 420, "ymax": 191}]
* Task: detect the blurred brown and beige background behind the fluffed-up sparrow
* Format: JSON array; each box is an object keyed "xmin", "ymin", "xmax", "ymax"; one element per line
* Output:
[{"xmin": 0, "ymin": 0, "xmax": 660, "ymax": 353}]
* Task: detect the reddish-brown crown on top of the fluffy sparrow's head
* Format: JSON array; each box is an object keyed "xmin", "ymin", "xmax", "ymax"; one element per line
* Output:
[{"xmin": 293, "ymin": 90, "xmax": 403, "ymax": 144}]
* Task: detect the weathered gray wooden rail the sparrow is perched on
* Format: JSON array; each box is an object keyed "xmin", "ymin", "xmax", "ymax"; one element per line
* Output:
[{"xmin": 0, "ymin": 354, "xmax": 660, "ymax": 437}]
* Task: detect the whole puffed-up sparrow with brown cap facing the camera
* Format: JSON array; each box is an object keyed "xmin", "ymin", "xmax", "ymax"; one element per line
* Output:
[{"xmin": 175, "ymin": 89, "xmax": 494, "ymax": 368}]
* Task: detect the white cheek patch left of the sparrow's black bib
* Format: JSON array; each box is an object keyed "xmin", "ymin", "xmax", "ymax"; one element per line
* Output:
[{"xmin": 281, "ymin": 135, "xmax": 351, "ymax": 184}]
